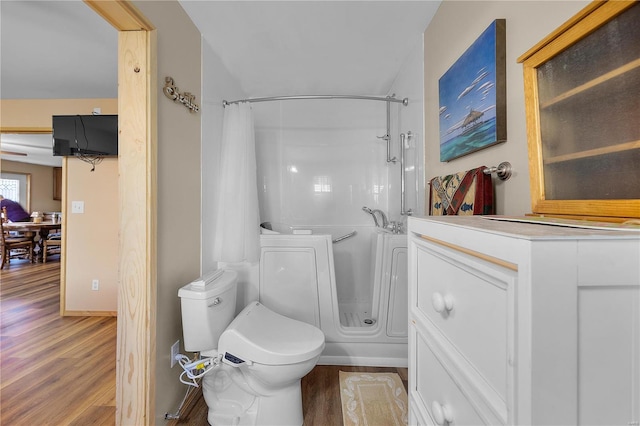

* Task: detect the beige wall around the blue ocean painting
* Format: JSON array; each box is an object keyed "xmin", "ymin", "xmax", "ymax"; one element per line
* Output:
[{"xmin": 424, "ymin": 0, "xmax": 589, "ymax": 215}]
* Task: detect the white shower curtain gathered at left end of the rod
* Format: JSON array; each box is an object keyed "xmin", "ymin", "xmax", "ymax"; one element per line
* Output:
[{"xmin": 213, "ymin": 102, "xmax": 260, "ymax": 263}]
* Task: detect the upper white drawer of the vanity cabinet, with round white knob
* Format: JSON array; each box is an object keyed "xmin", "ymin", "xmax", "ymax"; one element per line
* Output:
[{"xmin": 415, "ymin": 246, "xmax": 515, "ymax": 399}]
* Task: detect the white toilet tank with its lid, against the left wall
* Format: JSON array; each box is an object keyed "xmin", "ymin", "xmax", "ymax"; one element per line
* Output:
[{"xmin": 178, "ymin": 270, "xmax": 238, "ymax": 352}]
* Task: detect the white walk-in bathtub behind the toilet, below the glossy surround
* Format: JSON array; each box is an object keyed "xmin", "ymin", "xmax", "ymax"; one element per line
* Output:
[{"xmin": 259, "ymin": 226, "xmax": 407, "ymax": 367}]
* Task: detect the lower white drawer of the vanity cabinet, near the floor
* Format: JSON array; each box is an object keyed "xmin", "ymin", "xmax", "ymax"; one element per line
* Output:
[{"xmin": 415, "ymin": 333, "xmax": 486, "ymax": 425}]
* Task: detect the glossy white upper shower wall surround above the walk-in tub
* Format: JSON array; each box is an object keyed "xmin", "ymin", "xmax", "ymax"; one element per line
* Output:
[{"xmin": 253, "ymin": 99, "xmax": 390, "ymax": 228}]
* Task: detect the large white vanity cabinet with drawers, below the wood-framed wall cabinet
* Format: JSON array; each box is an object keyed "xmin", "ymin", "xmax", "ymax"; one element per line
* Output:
[{"xmin": 408, "ymin": 216, "xmax": 640, "ymax": 426}]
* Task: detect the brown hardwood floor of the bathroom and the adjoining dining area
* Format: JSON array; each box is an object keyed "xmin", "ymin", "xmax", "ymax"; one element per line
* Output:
[{"xmin": 0, "ymin": 260, "xmax": 407, "ymax": 426}]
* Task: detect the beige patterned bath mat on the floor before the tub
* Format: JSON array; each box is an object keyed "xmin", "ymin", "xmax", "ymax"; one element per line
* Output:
[{"xmin": 340, "ymin": 371, "xmax": 408, "ymax": 426}]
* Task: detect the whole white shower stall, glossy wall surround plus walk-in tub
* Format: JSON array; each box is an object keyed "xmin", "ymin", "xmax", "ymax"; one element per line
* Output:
[{"xmin": 241, "ymin": 96, "xmax": 413, "ymax": 366}]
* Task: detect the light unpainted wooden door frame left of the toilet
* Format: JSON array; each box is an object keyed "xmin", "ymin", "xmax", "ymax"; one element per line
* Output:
[{"xmin": 84, "ymin": 0, "xmax": 157, "ymax": 425}]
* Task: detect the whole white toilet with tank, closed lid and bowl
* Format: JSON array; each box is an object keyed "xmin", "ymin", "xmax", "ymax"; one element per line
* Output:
[{"xmin": 178, "ymin": 271, "xmax": 324, "ymax": 426}]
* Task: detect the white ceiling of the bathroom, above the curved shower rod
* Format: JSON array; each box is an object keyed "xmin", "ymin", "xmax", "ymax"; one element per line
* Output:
[{"xmin": 180, "ymin": 0, "xmax": 440, "ymax": 97}]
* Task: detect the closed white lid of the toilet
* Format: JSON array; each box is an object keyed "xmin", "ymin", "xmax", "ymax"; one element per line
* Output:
[{"xmin": 218, "ymin": 302, "xmax": 324, "ymax": 365}]
